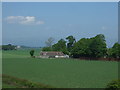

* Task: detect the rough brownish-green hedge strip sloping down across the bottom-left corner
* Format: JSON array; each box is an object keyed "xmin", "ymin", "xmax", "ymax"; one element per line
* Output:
[{"xmin": 2, "ymin": 74, "xmax": 54, "ymax": 88}]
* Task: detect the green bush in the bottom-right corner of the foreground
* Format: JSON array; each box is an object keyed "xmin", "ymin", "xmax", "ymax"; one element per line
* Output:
[{"xmin": 106, "ymin": 80, "xmax": 120, "ymax": 90}]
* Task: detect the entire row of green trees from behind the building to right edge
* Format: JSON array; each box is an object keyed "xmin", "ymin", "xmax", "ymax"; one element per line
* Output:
[{"xmin": 42, "ymin": 34, "xmax": 120, "ymax": 58}]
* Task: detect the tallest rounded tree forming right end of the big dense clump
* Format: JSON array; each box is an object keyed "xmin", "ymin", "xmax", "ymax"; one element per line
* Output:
[{"xmin": 90, "ymin": 34, "xmax": 107, "ymax": 57}]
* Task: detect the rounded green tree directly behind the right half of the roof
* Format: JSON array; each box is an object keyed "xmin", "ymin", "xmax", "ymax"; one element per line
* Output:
[{"xmin": 52, "ymin": 39, "xmax": 68, "ymax": 54}]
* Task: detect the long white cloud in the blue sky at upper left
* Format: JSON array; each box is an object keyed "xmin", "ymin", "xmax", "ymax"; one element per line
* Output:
[{"xmin": 5, "ymin": 16, "xmax": 44, "ymax": 25}]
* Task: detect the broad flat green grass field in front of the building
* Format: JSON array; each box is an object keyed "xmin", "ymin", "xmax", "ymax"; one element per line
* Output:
[{"xmin": 2, "ymin": 50, "xmax": 118, "ymax": 88}]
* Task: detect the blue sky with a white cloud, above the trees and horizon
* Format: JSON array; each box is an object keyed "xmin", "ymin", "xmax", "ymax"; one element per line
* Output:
[{"xmin": 2, "ymin": 2, "xmax": 118, "ymax": 47}]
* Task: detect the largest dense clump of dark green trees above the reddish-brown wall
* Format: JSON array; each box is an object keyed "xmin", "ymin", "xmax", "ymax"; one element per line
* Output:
[{"xmin": 71, "ymin": 34, "xmax": 107, "ymax": 58}]
